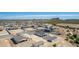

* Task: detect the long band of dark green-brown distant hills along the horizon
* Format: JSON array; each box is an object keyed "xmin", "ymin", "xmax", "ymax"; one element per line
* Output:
[{"xmin": 0, "ymin": 18, "xmax": 79, "ymax": 24}]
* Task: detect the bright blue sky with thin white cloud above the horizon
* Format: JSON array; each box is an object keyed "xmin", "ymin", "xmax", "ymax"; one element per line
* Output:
[{"xmin": 0, "ymin": 12, "xmax": 79, "ymax": 19}]
